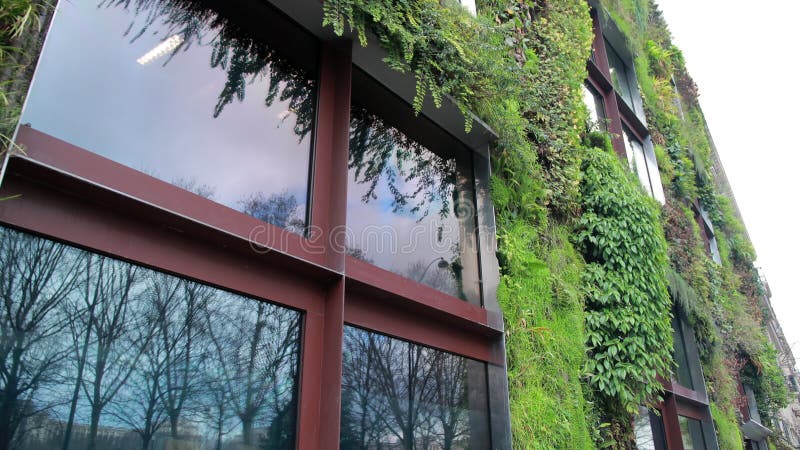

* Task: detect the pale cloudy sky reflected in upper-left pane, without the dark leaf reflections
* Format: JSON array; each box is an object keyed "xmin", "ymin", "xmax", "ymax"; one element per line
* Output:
[{"xmin": 21, "ymin": 0, "xmax": 313, "ymax": 232}]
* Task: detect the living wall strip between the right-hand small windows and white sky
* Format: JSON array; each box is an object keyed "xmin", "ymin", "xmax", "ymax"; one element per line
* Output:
[{"xmin": 604, "ymin": 0, "xmax": 787, "ymax": 449}]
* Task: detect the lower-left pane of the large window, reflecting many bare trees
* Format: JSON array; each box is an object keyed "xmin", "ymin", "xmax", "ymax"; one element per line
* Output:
[{"xmin": 0, "ymin": 228, "xmax": 301, "ymax": 450}]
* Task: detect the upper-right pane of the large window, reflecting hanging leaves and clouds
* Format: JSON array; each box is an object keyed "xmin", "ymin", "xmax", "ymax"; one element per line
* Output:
[{"xmin": 347, "ymin": 106, "xmax": 480, "ymax": 303}]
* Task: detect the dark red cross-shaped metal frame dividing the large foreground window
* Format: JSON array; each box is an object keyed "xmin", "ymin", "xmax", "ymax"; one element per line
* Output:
[{"xmin": 0, "ymin": 20, "xmax": 504, "ymax": 450}]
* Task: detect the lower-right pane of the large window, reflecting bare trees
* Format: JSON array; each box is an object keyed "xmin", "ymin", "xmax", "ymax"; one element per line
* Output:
[{"xmin": 340, "ymin": 326, "xmax": 490, "ymax": 450}]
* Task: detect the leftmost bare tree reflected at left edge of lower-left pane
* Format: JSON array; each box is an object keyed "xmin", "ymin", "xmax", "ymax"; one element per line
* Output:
[{"xmin": 0, "ymin": 228, "xmax": 80, "ymax": 448}]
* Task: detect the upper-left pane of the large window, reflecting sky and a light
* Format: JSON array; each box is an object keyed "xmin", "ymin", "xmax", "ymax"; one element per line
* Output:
[{"xmin": 21, "ymin": 0, "xmax": 316, "ymax": 232}]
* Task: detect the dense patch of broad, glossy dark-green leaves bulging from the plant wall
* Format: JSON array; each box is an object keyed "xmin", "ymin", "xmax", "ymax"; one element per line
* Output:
[{"xmin": 574, "ymin": 141, "xmax": 672, "ymax": 428}]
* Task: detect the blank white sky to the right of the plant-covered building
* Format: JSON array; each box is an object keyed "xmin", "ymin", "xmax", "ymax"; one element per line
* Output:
[{"xmin": 657, "ymin": 0, "xmax": 800, "ymax": 370}]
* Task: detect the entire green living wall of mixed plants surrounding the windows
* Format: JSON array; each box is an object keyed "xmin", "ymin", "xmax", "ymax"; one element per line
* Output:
[{"xmin": 0, "ymin": 0, "xmax": 785, "ymax": 449}]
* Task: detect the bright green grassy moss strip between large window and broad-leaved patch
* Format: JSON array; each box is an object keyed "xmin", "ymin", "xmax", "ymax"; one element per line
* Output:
[{"xmin": 498, "ymin": 222, "xmax": 593, "ymax": 449}]
